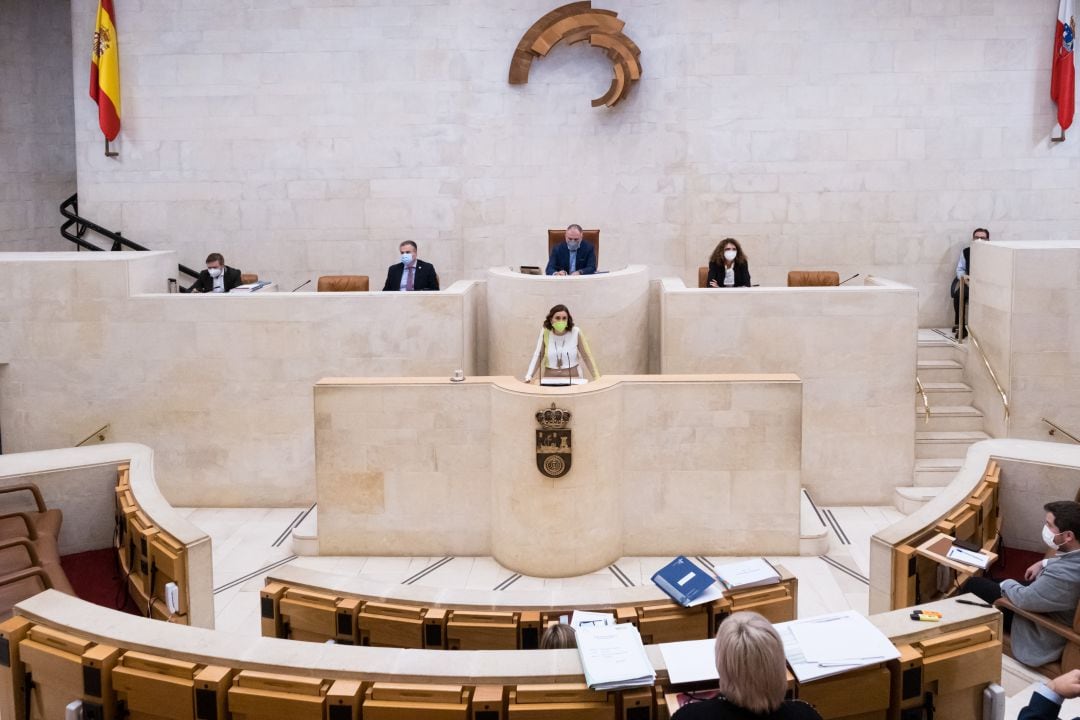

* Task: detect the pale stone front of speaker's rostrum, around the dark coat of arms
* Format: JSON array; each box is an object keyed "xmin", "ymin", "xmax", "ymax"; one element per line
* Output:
[{"xmin": 315, "ymin": 375, "xmax": 802, "ymax": 576}]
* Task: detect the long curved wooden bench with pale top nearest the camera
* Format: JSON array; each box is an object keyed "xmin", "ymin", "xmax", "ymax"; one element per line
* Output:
[{"xmin": 0, "ymin": 590, "xmax": 1001, "ymax": 720}]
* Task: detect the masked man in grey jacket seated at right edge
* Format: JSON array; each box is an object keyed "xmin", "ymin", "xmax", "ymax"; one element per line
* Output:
[{"xmin": 960, "ymin": 500, "xmax": 1080, "ymax": 667}]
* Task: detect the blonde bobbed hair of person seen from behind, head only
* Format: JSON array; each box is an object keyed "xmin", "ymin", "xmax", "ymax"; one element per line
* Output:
[{"xmin": 716, "ymin": 612, "xmax": 787, "ymax": 714}]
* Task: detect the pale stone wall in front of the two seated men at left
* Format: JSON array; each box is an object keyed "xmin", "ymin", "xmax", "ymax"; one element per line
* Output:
[{"xmin": 0, "ymin": 253, "xmax": 483, "ymax": 507}]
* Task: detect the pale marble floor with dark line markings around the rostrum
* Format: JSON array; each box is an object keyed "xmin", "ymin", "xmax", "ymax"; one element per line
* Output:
[{"xmin": 177, "ymin": 506, "xmax": 1054, "ymax": 719}]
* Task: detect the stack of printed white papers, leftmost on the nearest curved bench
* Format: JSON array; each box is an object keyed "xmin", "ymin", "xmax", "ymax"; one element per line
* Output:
[{"xmin": 577, "ymin": 623, "xmax": 657, "ymax": 690}]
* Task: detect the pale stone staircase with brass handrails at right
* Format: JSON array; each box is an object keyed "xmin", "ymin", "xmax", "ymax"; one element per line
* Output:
[{"xmin": 893, "ymin": 329, "xmax": 989, "ymax": 514}]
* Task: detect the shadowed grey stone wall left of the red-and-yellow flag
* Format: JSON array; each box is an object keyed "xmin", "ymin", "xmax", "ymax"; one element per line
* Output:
[{"xmin": 0, "ymin": 0, "xmax": 75, "ymax": 252}]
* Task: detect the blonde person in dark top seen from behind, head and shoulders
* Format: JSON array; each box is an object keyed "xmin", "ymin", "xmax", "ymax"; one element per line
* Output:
[{"xmin": 672, "ymin": 611, "xmax": 821, "ymax": 720}]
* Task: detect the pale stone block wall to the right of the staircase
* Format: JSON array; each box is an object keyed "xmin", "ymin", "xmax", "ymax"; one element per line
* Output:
[{"xmin": 966, "ymin": 241, "xmax": 1080, "ymax": 439}]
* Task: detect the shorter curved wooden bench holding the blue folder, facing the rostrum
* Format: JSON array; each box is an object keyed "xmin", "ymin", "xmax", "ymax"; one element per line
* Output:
[{"xmin": 260, "ymin": 566, "xmax": 798, "ymax": 650}]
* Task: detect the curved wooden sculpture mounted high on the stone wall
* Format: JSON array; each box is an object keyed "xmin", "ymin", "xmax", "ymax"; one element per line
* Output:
[{"xmin": 510, "ymin": 2, "xmax": 642, "ymax": 108}]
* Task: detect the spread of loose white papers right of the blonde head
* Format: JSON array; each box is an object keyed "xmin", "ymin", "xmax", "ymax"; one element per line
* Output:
[{"xmin": 774, "ymin": 610, "xmax": 900, "ymax": 682}]
